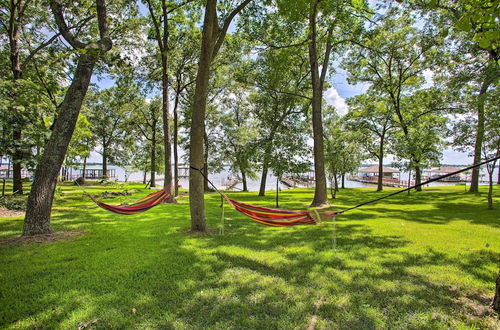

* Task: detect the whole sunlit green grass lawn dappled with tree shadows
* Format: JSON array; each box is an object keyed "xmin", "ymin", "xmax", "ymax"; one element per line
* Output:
[{"xmin": 0, "ymin": 185, "xmax": 500, "ymax": 329}]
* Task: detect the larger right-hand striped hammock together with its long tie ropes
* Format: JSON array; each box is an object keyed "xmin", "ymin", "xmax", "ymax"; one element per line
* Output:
[{"xmin": 190, "ymin": 156, "xmax": 500, "ymax": 227}]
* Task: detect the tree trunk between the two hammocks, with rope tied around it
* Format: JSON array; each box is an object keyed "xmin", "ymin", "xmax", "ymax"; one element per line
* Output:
[{"xmin": 189, "ymin": 0, "xmax": 218, "ymax": 232}]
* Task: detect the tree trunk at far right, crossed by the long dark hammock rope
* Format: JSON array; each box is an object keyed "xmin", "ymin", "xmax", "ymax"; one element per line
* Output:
[{"xmin": 469, "ymin": 74, "xmax": 491, "ymax": 193}]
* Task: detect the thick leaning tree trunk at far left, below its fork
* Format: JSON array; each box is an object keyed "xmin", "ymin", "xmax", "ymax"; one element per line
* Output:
[{"xmin": 23, "ymin": 54, "xmax": 97, "ymax": 236}]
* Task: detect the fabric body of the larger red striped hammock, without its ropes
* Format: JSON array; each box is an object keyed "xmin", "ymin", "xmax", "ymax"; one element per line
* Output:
[{"xmin": 222, "ymin": 194, "xmax": 337, "ymax": 227}]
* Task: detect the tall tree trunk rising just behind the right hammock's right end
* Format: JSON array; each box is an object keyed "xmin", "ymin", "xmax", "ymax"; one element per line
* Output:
[{"xmin": 308, "ymin": 2, "xmax": 328, "ymax": 206}]
